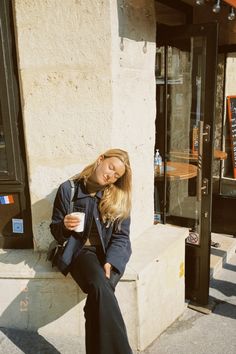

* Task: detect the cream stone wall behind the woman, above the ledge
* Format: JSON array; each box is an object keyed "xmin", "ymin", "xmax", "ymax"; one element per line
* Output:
[{"xmin": 13, "ymin": 0, "xmax": 155, "ymax": 250}]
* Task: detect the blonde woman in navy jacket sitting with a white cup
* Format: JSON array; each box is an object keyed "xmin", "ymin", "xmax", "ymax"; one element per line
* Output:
[{"xmin": 50, "ymin": 149, "xmax": 132, "ymax": 354}]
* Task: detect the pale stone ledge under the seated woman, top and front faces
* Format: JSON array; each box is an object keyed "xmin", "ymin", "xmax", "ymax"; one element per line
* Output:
[{"xmin": 0, "ymin": 224, "xmax": 188, "ymax": 353}]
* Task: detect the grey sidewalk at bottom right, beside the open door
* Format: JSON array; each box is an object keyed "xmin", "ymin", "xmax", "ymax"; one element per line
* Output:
[{"xmin": 142, "ymin": 241, "xmax": 236, "ymax": 354}]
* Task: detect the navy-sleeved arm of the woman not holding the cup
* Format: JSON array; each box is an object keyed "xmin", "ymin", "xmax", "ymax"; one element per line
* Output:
[{"xmin": 106, "ymin": 218, "xmax": 132, "ymax": 274}]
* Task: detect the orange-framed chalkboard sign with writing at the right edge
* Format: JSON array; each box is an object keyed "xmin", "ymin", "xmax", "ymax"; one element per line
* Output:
[{"xmin": 227, "ymin": 96, "xmax": 236, "ymax": 178}]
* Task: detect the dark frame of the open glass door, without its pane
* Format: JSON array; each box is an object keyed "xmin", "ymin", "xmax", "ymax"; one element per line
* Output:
[{"xmin": 157, "ymin": 23, "xmax": 218, "ymax": 305}]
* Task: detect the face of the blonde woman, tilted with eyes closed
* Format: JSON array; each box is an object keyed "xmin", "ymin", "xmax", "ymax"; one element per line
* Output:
[{"xmin": 91, "ymin": 156, "xmax": 125, "ymax": 186}]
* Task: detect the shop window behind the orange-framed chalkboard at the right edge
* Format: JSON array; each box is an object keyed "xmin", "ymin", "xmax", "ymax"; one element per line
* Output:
[{"xmin": 212, "ymin": 52, "xmax": 236, "ymax": 236}]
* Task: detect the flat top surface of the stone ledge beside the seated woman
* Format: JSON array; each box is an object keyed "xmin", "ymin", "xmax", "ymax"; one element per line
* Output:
[{"xmin": 0, "ymin": 224, "xmax": 188, "ymax": 281}]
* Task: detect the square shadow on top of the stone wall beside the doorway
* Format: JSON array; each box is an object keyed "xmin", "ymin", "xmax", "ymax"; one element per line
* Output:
[{"xmin": 117, "ymin": 0, "xmax": 156, "ymax": 45}]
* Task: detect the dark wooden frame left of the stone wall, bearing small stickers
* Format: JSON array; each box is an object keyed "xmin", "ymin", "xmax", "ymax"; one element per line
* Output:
[{"xmin": 0, "ymin": 0, "xmax": 33, "ymax": 248}]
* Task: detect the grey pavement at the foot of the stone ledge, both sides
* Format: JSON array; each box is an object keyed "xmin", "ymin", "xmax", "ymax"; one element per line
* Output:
[{"xmin": 0, "ymin": 234, "xmax": 236, "ymax": 354}]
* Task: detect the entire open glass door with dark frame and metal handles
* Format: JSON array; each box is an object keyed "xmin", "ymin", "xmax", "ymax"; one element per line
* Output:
[{"xmin": 155, "ymin": 24, "xmax": 217, "ymax": 304}]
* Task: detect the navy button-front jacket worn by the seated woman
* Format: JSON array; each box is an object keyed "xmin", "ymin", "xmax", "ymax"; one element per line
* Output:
[{"xmin": 50, "ymin": 181, "xmax": 131, "ymax": 275}]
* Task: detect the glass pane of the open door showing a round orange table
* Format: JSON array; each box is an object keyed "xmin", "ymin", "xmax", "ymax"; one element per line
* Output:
[{"xmin": 154, "ymin": 37, "xmax": 206, "ymax": 244}]
